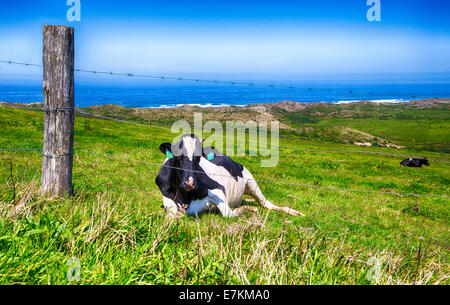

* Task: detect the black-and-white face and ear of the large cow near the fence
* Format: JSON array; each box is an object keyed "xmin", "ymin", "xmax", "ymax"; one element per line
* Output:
[{"xmin": 159, "ymin": 134, "xmax": 202, "ymax": 192}]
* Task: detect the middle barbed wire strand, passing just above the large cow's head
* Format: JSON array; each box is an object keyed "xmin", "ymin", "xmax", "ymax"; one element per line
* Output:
[{"xmin": 6, "ymin": 106, "xmax": 450, "ymax": 164}]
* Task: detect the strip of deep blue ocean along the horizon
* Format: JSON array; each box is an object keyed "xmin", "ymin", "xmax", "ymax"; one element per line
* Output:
[{"xmin": 0, "ymin": 75, "xmax": 450, "ymax": 108}]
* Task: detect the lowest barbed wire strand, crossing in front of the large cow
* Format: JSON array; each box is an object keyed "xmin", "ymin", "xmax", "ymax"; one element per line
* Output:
[{"xmin": 0, "ymin": 148, "xmax": 450, "ymax": 199}]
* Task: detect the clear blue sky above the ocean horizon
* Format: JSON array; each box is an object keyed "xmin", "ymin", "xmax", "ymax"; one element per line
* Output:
[{"xmin": 0, "ymin": 0, "xmax": 450, "ymax": 80}]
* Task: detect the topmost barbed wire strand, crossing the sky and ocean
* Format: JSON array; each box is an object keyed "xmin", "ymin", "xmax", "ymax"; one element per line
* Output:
[{"xmin": 0, "ymin": 60, "xmax": 426, "ymax": 98}]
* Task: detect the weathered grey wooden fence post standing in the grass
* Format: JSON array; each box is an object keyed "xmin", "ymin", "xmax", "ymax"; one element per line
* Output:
[{"xmin": 41, "ymin": 25, "xmax": 74, "ymax": 196}]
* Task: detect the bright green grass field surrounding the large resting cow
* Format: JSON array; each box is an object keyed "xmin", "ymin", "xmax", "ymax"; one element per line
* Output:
[{"xmin": 0, "ymin": 107, "xmax": 450, "ymax": 285}]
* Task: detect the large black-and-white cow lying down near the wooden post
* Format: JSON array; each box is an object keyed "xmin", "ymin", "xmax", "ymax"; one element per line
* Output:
[{"xmin": 155, "ymin": 134, "xmax": 304, "ymax": 217}]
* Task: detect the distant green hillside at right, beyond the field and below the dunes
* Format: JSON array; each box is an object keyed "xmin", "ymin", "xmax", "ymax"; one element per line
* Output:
[{"xmin": 274, "ymin": 100, "xmax": 450, "ymax": 153}]
